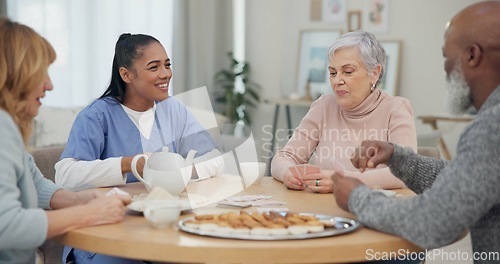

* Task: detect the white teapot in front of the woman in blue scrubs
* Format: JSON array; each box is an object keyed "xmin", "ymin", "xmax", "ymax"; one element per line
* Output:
[{"xmin": 132, "ymin": 147, "xmax": 196, "ymax": 196}]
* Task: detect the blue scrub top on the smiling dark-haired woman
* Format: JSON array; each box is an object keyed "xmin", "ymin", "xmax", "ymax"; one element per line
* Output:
[{"xmin": 61, "ymin": 97, "xmax": 215, "ymax": 182}]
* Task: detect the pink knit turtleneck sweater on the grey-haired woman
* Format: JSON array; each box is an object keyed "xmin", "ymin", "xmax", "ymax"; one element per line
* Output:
[{"xmin": 271, "ymin": 89, "xmax": 417, "ymax": 189}]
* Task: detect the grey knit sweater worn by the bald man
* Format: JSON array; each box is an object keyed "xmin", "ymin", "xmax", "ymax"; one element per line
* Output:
[{"xmin": 348, "ymin": 86, "xmax": 500, "ymax": 263}]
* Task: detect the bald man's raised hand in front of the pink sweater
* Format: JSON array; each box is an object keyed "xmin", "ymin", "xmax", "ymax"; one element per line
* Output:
[{"xmin": 351, "ymin": 140, "xmax": 394, "ymax": 172}]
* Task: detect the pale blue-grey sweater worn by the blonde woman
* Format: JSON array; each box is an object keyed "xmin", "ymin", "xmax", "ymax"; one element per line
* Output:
[{"xmin": 0, "ymin": 110, "xmax": 60, "ymax": 264}]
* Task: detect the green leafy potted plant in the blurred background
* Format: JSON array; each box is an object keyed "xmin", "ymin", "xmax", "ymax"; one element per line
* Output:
[{"xmin": 214, "ymin": 52, "xmax": 260, "ymax": 125}]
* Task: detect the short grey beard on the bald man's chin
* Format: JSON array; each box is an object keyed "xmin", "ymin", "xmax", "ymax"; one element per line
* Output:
[{"xmin": 446, "ymin": 65, "xmax": 472, "ymax": 115}]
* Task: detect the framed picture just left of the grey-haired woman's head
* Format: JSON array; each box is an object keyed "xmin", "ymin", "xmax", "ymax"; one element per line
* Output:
[{"xmin": 297, "ymin": 30, "xmax": 342, "ymax": 99}]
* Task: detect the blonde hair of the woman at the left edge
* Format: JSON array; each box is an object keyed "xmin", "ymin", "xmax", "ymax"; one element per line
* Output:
[{"xmin": 0, "ymin": 18, "xmax": 56, "ymax": 144}]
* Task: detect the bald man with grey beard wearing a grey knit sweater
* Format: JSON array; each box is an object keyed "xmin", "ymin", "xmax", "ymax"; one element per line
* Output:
[{"xmin": 332, "ymin": 1, "xmax": 500, "ymax": 263}]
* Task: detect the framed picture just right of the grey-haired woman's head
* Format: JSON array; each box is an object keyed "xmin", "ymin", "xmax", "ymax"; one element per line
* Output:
[{"xmin": 378, "ymin": 40, "xmax": 401, "ymax": 95}]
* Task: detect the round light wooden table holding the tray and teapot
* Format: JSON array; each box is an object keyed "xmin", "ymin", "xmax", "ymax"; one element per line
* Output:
[{"xmin": 55, "ymin": 177, "xmax": 421, "ymax": 263}]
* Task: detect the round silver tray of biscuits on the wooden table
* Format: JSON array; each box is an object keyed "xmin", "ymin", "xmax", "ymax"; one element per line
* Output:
[{"xmin": 178, "ymin": 210, "xmax": 360, "ymax": 240}]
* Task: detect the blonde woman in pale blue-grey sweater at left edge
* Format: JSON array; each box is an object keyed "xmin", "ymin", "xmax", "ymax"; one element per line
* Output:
[{"xmin": 0, "ymin": 19, "xmax": 130, "ymax": 263}]
